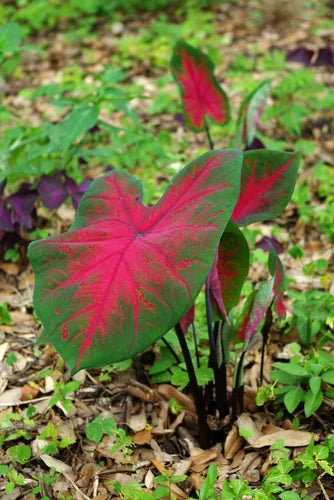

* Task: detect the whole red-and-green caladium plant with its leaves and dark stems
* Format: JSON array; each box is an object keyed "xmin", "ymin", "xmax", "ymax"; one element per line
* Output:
[{"xmin": 27, "ymin": 42, "xmax": 300, "ymax": 447}]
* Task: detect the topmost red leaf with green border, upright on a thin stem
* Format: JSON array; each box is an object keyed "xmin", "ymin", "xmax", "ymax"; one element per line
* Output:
[{"xmin": 171, "ymin": 41, "xmax": 230, "ymax": 132}]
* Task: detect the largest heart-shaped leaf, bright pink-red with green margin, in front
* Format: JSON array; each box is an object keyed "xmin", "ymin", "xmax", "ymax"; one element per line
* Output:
[{"xmin": 28, "ymin": 149, "xmax": 242, "ymax": 371}]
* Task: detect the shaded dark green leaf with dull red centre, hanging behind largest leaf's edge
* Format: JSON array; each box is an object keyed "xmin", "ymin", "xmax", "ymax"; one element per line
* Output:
[{"xmin": 217, "ymin": 220, "xmax": 249, "ymax": 312}]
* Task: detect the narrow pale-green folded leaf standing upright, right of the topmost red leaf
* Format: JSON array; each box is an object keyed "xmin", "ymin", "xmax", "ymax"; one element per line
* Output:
[{"xmin": 235, "ymin": 80, "xmax": 271, "ymax": 146}]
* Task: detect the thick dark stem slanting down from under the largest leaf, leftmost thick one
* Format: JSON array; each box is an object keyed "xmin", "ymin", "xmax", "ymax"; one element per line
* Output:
[{"xmin": 175, "ymin": 323, "xmax": 210, "ymax": 449}]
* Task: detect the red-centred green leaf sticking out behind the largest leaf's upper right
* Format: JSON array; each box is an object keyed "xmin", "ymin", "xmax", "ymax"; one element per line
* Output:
[{"xmin": 232, "ymin": 149, "xmax": 301, "ymax": 226}]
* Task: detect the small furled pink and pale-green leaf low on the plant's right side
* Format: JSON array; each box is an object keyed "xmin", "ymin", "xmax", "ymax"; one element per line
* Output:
[{"xmin": 238, "ymin": 279, "xmax": 274, "ymax": 349}]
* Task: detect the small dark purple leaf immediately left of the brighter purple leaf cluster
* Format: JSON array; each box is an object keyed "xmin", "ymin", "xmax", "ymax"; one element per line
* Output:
[{"xmin": 7, "ymin": 183, "xmax": 38, "ymax": 229}]
